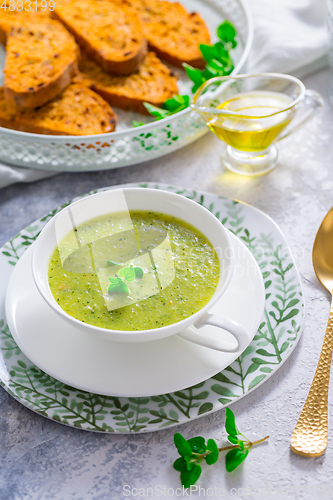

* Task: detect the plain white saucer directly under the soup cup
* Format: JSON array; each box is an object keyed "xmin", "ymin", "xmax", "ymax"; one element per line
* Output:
[{"xmin": 6, "ymin": 234, "xmax": 265, "ymax": 397}]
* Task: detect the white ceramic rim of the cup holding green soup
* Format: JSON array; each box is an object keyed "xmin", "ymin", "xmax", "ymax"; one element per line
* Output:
[{"xmin": 32, "ymin": 187, "xmax": 234, "ymax": 342}]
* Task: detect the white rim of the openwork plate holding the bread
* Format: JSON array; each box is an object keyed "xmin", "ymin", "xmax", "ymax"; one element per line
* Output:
[{"xmin": 0, "ymin": 0, "xmax": 253, "ymax": 142}]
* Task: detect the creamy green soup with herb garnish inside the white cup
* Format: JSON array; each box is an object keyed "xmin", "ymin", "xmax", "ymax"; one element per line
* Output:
[{"xmin": 48, "ymin": 211, "xmax": 220, "ymax": 331}]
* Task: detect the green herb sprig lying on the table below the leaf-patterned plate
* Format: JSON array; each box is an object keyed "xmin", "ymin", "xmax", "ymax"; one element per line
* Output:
[{"xmin": 173, "ymin": 408, "xmax": 269, "ymax": 488}]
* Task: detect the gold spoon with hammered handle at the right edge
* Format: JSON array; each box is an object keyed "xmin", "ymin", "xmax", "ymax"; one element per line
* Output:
[{"xmin": 290, "ymin": 208, "xmax": 333, "ymax": 457}]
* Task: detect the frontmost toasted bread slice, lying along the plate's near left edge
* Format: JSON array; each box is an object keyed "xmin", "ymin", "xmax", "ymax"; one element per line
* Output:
[{"xmin": 0, "ymin": 83, "xmax": 117, "ymax": 135}]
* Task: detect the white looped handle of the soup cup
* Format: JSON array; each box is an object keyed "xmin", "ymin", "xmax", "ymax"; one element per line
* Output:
[{"xmin": 178, "ymin": 314, "xmax": 250, "ymax": 352}]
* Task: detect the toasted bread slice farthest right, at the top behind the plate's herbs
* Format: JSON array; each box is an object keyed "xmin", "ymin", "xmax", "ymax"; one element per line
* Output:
[{"xmin": 112, "ymin": 0, "xmax": 210, "ymax": 68}]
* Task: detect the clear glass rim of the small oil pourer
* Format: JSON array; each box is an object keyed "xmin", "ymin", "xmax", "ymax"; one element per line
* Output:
[{"xmin": 191, "ymin": 73, "xmax": 306, "ymax": 120}]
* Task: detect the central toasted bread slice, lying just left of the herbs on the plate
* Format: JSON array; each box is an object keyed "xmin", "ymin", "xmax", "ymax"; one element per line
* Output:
[{"xmin": 79, "ymin": 52, "xmax": 178, "ymax": 114}]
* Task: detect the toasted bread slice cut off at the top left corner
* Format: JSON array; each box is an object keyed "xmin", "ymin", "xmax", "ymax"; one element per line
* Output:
[{"xmin": 0, "ymin": 6, "xmax": 50, "ymax": 45}]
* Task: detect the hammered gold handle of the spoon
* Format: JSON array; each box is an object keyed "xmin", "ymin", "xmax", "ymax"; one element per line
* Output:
[{"xmin": 290, "ymin": 298, "xmax": 333, "ymax": 457}]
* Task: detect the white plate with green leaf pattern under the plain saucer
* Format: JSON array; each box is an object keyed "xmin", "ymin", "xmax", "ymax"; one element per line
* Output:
[{"xmin": 0, "ymin": 184, "xmax": 304, "ymax": 433}]
